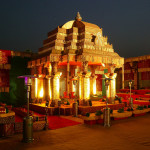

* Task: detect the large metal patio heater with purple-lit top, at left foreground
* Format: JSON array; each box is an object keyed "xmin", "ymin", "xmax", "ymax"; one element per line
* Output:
[{"xmin": 18, "ymin": 75, "xmax": 35, "ymax": 143}]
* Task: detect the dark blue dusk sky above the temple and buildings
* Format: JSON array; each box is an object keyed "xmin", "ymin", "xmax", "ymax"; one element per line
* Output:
[{"xmin": 0, "ymin": 0, "xmax": 150, "ymax": 58}]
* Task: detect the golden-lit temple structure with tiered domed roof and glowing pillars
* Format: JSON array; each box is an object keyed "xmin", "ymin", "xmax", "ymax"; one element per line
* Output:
[{"xmin": 28, "ymin": 13, "xmax": 124, "ymax": 107}]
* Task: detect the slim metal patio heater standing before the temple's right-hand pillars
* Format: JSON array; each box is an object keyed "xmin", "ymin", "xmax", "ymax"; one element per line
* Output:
[{"xmin": 104, "ymin": 78, "xmax": 111, "ymax": 127}]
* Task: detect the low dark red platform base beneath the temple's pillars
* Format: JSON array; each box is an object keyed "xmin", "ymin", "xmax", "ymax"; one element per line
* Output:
[{"xmin": 29, "ymin": 102, "xmax": 125, "ymax": 116}]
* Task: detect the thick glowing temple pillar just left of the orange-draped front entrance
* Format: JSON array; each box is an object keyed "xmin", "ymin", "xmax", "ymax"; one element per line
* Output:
[{"xmin": 50, "ymin": 62, "xmax": 61, "ymax": 107}]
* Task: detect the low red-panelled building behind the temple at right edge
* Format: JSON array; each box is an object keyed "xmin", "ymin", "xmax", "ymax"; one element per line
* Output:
[{"xmin": 116, "ymin": 55, "xmax": 150, "ymax": 90}]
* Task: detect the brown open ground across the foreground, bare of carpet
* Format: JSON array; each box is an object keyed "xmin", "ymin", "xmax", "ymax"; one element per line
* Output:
[{"xmin": 0, "ymin": 113, "xmax": 150, "ymax": 150}]
